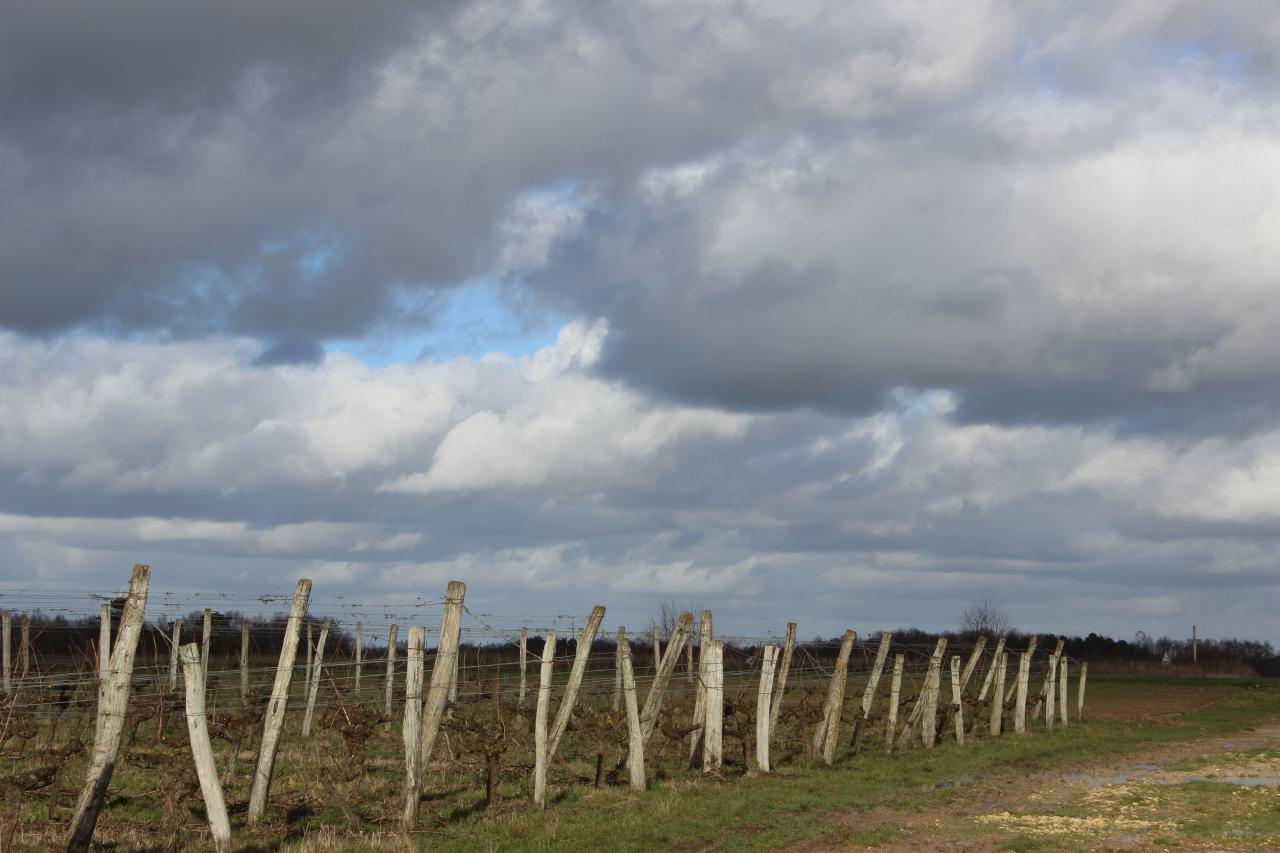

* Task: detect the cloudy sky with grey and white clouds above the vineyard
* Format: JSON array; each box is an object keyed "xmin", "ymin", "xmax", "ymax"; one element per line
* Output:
[{"xmin": 0, "ymin": 0, "xmax": 1280, "ymax": 640}]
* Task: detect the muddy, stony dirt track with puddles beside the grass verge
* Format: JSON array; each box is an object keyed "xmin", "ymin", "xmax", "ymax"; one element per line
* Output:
[{"xmin": 795, "ymin": 706, "xmax": 1280, "ymax": 853}]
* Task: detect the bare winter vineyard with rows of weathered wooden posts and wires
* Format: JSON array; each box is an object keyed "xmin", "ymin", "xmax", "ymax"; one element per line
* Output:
[{"xmin": 0, "ymin": 566, "xmax": 1087, "ymax": 849}]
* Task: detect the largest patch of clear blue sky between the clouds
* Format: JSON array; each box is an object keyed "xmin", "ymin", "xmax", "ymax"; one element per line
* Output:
[{"xmin": 325, "ymin": 279, "xmax": 568, "ymax": 368}]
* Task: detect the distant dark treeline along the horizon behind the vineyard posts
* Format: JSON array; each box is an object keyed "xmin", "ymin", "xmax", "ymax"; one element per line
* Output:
[{"xmin": 12, "ymin": 599, "xmax": 1280, "ymax": 676}]
